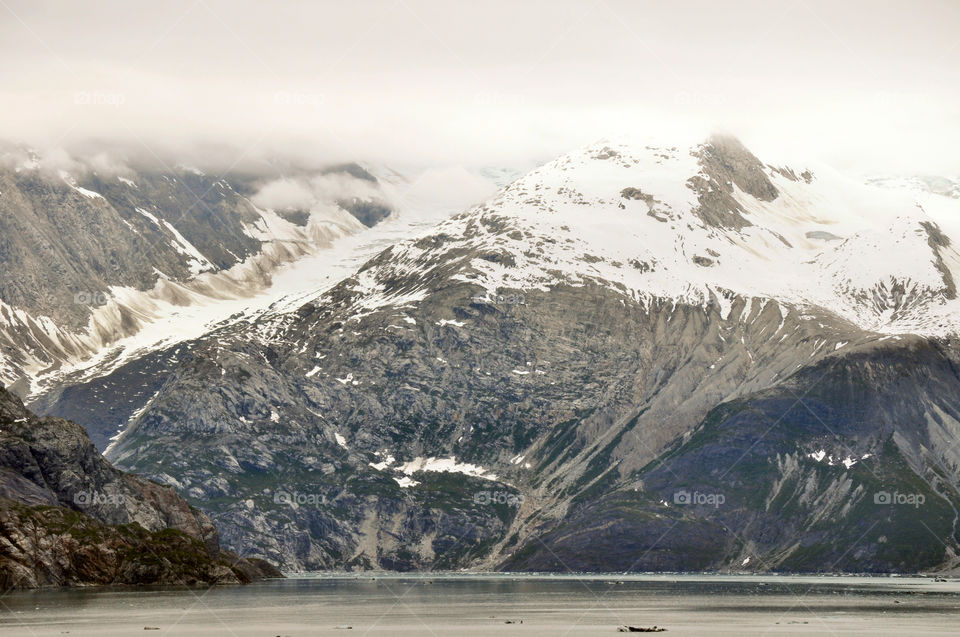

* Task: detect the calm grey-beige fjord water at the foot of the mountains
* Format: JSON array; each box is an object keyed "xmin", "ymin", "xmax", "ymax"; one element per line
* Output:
[{"xmin": 0, "ymin": 574, "xmax": 960, "ymax": 637}]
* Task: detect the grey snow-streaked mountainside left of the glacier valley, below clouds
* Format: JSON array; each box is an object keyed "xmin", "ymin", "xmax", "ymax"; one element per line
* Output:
[{"xmin": 0, "ymin": 147, "xmax": 390, "ymax": 395}]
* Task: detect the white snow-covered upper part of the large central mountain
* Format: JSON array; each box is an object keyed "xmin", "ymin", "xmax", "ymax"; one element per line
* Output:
[{"xmin": 382, "ymin": 139, "xmax": 960, "ymax": 335}]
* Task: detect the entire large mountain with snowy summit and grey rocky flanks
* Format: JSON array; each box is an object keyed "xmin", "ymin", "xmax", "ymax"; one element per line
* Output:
[{"xmin": 30, "ymin": 138, "xmax": 960, "ymax": 571}]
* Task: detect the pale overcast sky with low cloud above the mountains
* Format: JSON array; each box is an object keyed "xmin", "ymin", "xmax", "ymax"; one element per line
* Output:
[{"xmin": 0, "ymin": 0, "xmax": 960, "ymax": 175}]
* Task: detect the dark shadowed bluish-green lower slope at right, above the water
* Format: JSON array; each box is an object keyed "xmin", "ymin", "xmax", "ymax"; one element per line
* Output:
[{"xmin": 501, "ymin": 338, "xmax": 960, "ymax": 572}]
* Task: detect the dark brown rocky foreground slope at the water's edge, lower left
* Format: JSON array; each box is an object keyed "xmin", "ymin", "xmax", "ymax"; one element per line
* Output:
[{"xmin": 0, "ymin": 389, "xmax": 278, "ymax": 590}]
